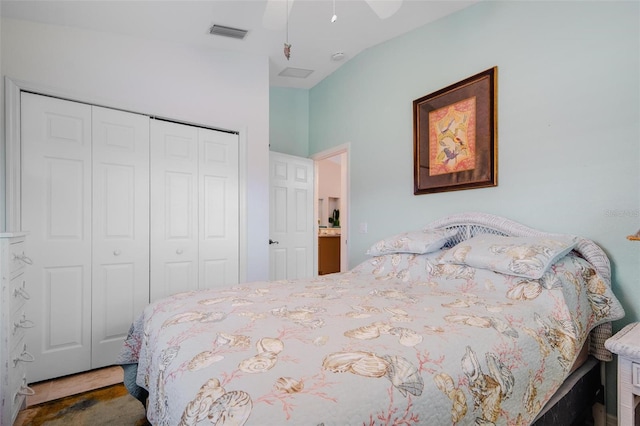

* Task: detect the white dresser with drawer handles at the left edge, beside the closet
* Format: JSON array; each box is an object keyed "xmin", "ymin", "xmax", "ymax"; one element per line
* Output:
[{"xmin": 0, "ymin": 232, "xmax": 33, "ymax": 426}]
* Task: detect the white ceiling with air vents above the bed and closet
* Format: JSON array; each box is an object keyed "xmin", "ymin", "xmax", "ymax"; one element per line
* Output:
[{"xmin": 0, "ymin": 0, "xmax": 479, "ymax": 89}]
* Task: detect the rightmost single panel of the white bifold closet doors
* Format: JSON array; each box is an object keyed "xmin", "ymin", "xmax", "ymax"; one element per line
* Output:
[{"xmin": 198, "ymin": 129, "xmax": 240, "ymax": 288}]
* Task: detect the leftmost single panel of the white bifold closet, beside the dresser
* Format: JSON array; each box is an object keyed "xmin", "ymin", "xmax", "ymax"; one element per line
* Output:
[{"xmin": 21, "ymin": 93, "xmax": 91, "ymax": 382}]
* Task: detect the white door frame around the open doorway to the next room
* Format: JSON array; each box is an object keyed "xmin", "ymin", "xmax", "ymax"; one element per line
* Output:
[{"xmin": 310, "ymin": 142, "xmax": 351, "ymax": 272}]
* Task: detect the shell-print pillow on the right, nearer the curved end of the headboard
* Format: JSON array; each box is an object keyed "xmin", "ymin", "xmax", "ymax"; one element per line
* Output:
[{"xmin": 440, "ymin": 234, "xmax": 578, "ymax": 279}]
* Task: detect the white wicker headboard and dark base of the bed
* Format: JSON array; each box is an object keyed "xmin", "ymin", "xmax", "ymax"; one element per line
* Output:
[{"xmin": 426, "ymin": 212, "xmax": 613, "ymax": 426}]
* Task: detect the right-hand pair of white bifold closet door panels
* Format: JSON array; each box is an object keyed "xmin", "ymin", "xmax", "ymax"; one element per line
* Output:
[{"xmin": 151, "ymin": 120, "xmax": 239, "ymax": 301}]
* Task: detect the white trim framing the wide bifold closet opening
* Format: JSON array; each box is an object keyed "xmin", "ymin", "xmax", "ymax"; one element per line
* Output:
[{"xmin": 0, "ymin": 76, "xmax": 248, "ymax": 283}]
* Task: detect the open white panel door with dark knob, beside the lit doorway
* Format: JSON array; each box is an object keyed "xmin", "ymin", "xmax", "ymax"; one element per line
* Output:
[{"xmin": 269, "ymin": 152, "xmax": 315, "ymax": 280}]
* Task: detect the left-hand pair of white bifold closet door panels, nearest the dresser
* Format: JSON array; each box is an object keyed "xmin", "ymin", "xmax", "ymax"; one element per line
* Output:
[{"xmin": 21, "ymin": 93, "xmax": 149, "ymax": 382}]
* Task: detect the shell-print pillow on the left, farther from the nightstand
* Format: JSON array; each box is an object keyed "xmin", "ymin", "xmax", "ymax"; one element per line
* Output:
[{"xmin": 367, "ymin": 229, "xmax": 458, "ymax": 256}]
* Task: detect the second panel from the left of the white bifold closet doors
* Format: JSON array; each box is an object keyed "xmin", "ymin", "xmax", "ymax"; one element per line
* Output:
[{"xmin": 91, "ymin": 106, "xmax": 149, "ymax": 368}]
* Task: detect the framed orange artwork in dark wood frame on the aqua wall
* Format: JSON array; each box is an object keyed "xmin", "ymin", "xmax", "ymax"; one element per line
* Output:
[{"xmin": 413, "ymin": 67, "xmax": 498, "ymax": 195}]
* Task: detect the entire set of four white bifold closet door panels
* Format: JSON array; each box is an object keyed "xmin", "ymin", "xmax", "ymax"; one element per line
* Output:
[{"xmin": 21, "ymin": 93, "xmax": 239, "ymax": 382}]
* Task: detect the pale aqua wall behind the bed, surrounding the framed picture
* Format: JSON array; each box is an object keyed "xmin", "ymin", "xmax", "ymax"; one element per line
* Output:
[{"xmin": 309, "ymin": 1, "xmax": 640, "ymax": 412}]
